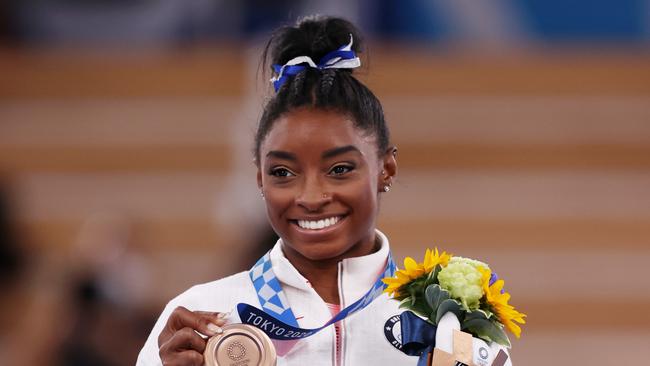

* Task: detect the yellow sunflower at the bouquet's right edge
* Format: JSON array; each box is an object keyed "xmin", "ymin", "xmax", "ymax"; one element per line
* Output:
[{"xmin": 478, "ymin": 267, "xmax": 526, "ymax": 338}]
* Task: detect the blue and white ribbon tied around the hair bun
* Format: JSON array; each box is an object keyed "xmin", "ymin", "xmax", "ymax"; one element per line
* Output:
[{"xmin": 271, "ymin": 34, "xmax": 361, "ymax": 92}]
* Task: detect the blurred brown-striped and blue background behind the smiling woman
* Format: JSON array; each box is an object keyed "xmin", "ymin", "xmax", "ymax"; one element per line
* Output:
[{"xmin": 0, "ymin": 0, "xmax": 650, "ymax": 366}]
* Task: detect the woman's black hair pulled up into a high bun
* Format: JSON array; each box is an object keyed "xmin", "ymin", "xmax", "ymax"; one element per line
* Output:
[{"xmin": 255, "ymin": 16, "xmax": 389, "ymax": 164}]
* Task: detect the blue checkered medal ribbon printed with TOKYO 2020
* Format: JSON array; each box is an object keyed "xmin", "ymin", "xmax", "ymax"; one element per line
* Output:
[{"xmin": 237, "ymin": 253, "xmax": 396, "ymax": 340}]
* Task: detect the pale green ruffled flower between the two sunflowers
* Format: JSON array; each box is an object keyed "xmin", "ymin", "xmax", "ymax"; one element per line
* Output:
[{"xmin": 438, "ymin": 257, "xmax": 487, "ymax": 311}]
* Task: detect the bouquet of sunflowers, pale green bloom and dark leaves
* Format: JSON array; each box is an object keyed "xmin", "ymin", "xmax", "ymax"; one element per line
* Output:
[{"xmin": 382, "ymin": 248, "xmax": 526, "ymax": 347}]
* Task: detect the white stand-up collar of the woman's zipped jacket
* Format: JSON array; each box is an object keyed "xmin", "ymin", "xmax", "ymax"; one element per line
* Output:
[{"xmin": 270, "ymin": 230, "xmax": 390, "ymax": 306}]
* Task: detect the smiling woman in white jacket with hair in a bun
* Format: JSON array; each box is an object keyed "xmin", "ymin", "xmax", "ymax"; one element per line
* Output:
[{"xmin": 138, "ymin": 18, "xmax": 512, "ymax": 365}]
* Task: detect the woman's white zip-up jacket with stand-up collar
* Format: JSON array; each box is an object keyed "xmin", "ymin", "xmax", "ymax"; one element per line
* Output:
[{"xmin": 137, "ymin": 231, "xmax": 418, "ymax": 366}]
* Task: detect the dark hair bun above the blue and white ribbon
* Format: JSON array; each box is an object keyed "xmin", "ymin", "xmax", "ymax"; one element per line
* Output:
[{"xmin": 264, "ymin": 16, "xmax": 363, "ymax": 71}]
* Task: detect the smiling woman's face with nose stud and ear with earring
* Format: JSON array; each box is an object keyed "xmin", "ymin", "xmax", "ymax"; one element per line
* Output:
[{"xmin": 258, "ymin": 108, "xmax": 396, "ymax": 261}]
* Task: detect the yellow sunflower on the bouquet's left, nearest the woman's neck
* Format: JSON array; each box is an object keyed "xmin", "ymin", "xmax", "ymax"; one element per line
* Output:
[{"xmin": 382, "ymin": 248, "xmax": 451, "ymax": 298}]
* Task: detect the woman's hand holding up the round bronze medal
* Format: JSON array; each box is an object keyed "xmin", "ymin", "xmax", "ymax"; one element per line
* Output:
[{"xmin": 158, "ymin": 306, "xmax": 226, "ymax": 366}]
